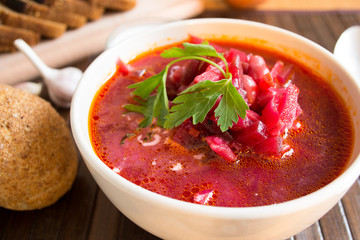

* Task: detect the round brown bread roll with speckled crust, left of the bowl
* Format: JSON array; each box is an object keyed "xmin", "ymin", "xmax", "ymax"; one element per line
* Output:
[{"xmin": 0, "ymin": 84, "xmax": 78, "ymax": 210}]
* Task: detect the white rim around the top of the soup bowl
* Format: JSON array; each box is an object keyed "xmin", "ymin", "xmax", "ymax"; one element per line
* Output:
[{"xmin": 70, "ymin": 18, "xmax": 360, "ymax": 219}]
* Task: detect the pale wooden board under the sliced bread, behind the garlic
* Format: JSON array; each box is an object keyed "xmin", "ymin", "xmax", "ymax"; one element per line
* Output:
[{"xmin": 0, "ymin": 0, "xmax": 203, "ymax": 84}]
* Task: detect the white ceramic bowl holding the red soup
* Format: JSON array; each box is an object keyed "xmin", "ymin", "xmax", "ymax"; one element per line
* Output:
[{"xmin": 71, "ymin": 19, "xmax": 360, "ymax": 240}]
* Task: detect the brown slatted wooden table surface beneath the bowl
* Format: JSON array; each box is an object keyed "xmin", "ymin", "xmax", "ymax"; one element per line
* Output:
[{"xmin": 0, "ymin": 9, "xmax": 360, "ymax": 240}]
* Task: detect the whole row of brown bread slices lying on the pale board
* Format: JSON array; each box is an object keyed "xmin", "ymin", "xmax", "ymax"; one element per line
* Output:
[{"xmin": 0, "ymin": 0, "xmax": 136, "ymax": 53}]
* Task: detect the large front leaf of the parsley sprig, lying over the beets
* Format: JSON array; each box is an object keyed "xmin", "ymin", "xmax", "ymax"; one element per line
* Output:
[{"xmin": 164, "ymin": 79, "xmax": 249, "ymax": 132}]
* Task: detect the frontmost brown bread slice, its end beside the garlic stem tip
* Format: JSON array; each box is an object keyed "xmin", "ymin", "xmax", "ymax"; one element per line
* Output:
[{"xmin": 0, "ymin": 24, "xmax": 40, "ymax": 52}]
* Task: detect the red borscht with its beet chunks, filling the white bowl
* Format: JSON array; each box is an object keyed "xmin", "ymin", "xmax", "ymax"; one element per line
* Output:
[{"xmin": 89, "ymin": 36, "xmax": 354, "ymax": 207}]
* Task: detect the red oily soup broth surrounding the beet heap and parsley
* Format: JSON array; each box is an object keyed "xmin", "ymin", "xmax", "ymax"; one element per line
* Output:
[{"xmin": 89, "ymin": 40, "xmax": 354, "ymax": 207}]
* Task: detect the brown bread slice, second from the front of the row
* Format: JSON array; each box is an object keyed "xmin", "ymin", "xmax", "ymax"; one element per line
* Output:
[{"xmin": 0, "ymin": 3, "xmax": 66, "ymax": 38}]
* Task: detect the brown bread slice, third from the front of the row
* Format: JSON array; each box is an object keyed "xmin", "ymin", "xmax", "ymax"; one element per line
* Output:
[{"xmin": 0, "ymin": 0, "xmax": 87, "ymax": 28}]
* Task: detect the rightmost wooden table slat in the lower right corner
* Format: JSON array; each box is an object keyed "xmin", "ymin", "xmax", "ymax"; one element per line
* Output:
[{"xmin": 342, "ymin": 179, "xmax": 360, "ymax": 239}]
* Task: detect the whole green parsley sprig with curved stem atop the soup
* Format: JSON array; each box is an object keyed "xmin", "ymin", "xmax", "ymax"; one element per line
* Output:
[{"xmin": 125, "ymin": 42, "xmax": 249, "ymax": 132}]
